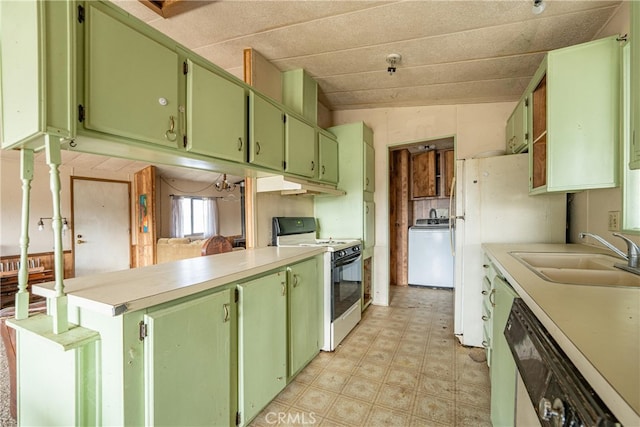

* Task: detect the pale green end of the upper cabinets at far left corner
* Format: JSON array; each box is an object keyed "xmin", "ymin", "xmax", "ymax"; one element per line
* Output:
[{"xmin": 0, "ymin": 1, "xmax": 77, "ymax": 148}]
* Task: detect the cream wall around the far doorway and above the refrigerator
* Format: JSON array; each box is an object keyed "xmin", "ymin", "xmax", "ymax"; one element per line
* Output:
[{"xmin": 333, "ymin": 102, "xmax": 515, "ymax": 305}]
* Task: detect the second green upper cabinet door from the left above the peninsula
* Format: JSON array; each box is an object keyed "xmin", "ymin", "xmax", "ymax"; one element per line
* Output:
[{"xmin": 186, "ymin": 60, "xmax": 247, "ymax": 162}]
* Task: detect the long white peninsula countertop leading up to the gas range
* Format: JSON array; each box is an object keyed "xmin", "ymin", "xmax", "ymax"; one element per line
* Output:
[{"xmin": 32, "ymin": 247, "xmax": 326, "ymax": 316}]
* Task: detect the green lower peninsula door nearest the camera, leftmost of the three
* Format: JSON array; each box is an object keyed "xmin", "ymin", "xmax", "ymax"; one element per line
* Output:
[{"xmin": 144, "ymin": 289, "xmax": 235, "ymax": 426}]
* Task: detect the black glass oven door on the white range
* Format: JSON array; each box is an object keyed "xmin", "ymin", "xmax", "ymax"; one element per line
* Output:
[{"xmin": 331, "ymin": 254, "xmax": 362, "ymax": 322}]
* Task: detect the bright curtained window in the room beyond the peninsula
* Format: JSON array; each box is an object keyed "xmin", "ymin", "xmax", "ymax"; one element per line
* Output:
[{"xmin": 171, "ymin": 196, "xmax": 218, "ymax": 238}]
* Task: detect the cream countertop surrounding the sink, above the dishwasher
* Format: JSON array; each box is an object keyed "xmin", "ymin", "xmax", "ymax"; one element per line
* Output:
[{"xmin": 483, "ymin": 244, "xmax": 640, "ymax": 426}]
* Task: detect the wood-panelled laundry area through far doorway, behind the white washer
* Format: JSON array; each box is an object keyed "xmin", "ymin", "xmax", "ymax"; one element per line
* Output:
[{"xmin": 389, "ymin": 136, "xmax": 455, "ymax": 286}]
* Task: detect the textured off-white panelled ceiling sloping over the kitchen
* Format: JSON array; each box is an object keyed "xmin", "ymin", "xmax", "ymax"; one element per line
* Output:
[{"xmin": 112, "ymin": 0, "xmax": 621, "ymax": 110}]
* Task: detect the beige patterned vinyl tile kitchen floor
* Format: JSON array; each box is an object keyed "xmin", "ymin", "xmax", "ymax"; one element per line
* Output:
[{"xmin": 251, "ymin": 286, "xmax": 491, "ymax": 427}]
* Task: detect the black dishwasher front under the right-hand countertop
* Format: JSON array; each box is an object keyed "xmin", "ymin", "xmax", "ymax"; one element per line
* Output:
[{"xmin": 504, "ymin": 298, "xmax": 620, "ymax": 427}]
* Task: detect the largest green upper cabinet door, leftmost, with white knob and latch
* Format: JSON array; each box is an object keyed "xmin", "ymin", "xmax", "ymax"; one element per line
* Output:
[{"xmin": 84, "ymin": 2, "xmax": 184, "ymax": 147}]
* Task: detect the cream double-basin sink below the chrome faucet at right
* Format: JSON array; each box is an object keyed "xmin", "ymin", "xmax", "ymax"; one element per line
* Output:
[{"xmin": 511, "ymin": 252, "xmax": 640, "ymax": 287}]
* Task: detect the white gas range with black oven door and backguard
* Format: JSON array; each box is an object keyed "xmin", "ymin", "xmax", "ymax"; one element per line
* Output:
[{"xmin": 272, "ymin": 217, "xmax": 362, "ymax": 351}]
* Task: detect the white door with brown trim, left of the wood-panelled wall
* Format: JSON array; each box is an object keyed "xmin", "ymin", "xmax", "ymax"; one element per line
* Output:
[{"xmin": 71, "ymin": 177, "xmax": 131, "ymax": 277}]
